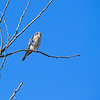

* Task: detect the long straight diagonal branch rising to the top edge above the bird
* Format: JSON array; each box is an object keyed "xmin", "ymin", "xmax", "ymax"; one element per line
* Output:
[{"xmin": 1, "ymin": 0, "xmax": 53, "ymax": 52}]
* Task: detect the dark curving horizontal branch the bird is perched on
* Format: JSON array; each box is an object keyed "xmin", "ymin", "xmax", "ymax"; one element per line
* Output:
[{"xmin": 0, "ymin": 50, "xmax": 80, "ymax": 59}]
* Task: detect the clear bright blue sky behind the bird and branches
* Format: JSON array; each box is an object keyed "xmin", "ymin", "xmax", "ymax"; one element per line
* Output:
[{"xmin": 0, "ymin": 0, "xmax": 100, "ymax": 100}]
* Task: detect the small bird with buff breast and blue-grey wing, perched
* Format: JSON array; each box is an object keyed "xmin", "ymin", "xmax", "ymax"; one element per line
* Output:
[{"xmin": 22, "ymin": 32, "xmax": 41, "ymax": 61}]
